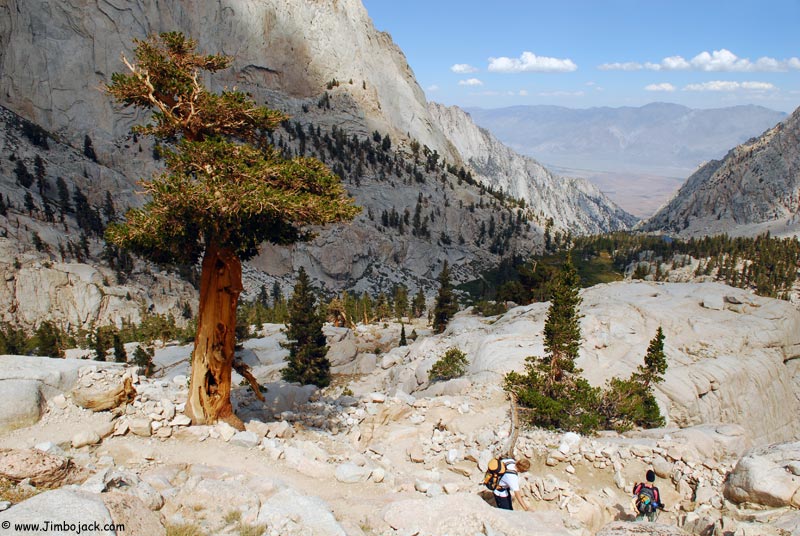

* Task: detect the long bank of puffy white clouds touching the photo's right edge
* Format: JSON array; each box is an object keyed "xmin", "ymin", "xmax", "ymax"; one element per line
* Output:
[{"xmin": 597, "ymin": 48, "xmax": 800, "ymax": 72}]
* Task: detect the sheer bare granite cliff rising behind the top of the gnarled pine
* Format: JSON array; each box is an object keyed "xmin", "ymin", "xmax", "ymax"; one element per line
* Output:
[{"xmin": 0, "ymin": 0, "xmax": 457, "ymax": 165}]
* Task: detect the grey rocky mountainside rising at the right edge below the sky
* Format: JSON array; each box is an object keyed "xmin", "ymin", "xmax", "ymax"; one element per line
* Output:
[{"xmin": 641, "ymin": 109, "xmax": 800, "ymax": 236}]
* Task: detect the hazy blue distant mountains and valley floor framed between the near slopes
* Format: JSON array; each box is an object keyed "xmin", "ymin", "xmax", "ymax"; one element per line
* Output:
[{"xmin": 467, "ymin": 103, "xmax": 786, "ymax": 217}]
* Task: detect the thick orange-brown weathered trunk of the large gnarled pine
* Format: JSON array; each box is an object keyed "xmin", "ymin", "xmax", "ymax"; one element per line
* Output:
[{"xmin": 186, "ymin": 242, "xmax": 244, "ymax": 430}]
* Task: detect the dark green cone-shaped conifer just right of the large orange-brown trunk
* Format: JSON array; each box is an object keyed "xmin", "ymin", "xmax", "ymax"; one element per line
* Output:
[{"xmin": 281, "ymin": 267, "xmax": 331, "ymax": 387}]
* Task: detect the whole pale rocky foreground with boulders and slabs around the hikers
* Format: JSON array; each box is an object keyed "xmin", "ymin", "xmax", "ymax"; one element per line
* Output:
[{"xmin": 0, "ymin": 283, "xmax": 800, "ymax": 536}]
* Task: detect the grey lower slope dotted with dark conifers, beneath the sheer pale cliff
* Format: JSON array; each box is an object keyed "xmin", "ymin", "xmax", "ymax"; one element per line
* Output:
[{"xmin": 0, "ymin": 100, "xmax": 543, "ymax": 328}]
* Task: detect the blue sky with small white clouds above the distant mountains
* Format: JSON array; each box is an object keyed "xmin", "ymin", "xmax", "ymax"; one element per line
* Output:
[{"xmin": 363, "ymin": 0, "xmax": 800, "ymax": 112}]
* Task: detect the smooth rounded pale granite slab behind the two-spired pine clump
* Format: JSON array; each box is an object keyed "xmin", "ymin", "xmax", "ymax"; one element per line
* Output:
[{"xmin": 383, "ymin": 282, "xmax": 800, "ymax": 442}]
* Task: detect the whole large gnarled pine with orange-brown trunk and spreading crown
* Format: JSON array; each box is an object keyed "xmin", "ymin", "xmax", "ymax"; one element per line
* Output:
[{"xmin": 106, "ymin": 32, "xmax": 359, "ymax": 429}]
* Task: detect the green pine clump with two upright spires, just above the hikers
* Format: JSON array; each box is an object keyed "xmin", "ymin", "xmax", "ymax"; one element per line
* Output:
[{"xmin": 505, "ymin": 255, "xmax": 667, "ymax": 434}]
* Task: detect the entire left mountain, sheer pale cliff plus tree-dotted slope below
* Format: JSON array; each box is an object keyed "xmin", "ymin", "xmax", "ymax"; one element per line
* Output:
[{"xmin": 0, "ymin": 0, "xmax": 632, "ymax": 326}]
